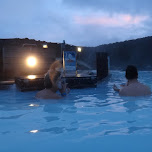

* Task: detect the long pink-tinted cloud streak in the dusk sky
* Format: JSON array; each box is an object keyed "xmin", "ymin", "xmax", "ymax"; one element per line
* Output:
[{"xmin": 75, "ymin": 14, "xmax": 149, "ymax": 27}]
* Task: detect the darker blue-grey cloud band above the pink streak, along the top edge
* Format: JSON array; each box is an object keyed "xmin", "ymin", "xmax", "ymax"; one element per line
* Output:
[{"xmin": 62, "ymin": 0, "xmax": 152, "ymax": 14}]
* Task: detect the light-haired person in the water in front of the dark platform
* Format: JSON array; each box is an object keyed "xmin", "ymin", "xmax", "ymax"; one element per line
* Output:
[{"xmin": 36, "ymin": 60, "xmax": 69, "ymax": 99}]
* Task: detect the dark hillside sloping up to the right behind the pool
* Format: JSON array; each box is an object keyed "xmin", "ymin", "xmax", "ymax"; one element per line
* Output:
[{"xmin": 81, "ymin": 36, "xmax": 152, "ymax": 70}]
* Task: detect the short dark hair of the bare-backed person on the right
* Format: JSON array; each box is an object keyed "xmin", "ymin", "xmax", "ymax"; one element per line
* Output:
[{"xmin": 126, "ymin": 65, "xmax": 138, "ymax": 79}]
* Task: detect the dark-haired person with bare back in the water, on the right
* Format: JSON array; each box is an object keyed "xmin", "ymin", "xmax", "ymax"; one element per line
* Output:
[{"xmin": 113, "ymin": 65, "xmax": 151, "ymax": 96}]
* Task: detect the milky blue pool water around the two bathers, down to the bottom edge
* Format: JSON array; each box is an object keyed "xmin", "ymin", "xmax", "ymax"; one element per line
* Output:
[{"xmin": 0, "ymin": 71, "xmax": 152, "ymax": 152}]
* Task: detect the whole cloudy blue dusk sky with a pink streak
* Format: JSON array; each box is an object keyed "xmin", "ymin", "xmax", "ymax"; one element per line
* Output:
[{"xmin": 0, "ymin": 0, "xmax": 152, "ymax": 46}]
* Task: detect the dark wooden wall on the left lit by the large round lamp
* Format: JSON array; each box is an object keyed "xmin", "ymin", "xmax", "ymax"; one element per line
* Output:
[{"xmin": 0, "ymin": 39, "xmax": 61, "ymax": 79}]
